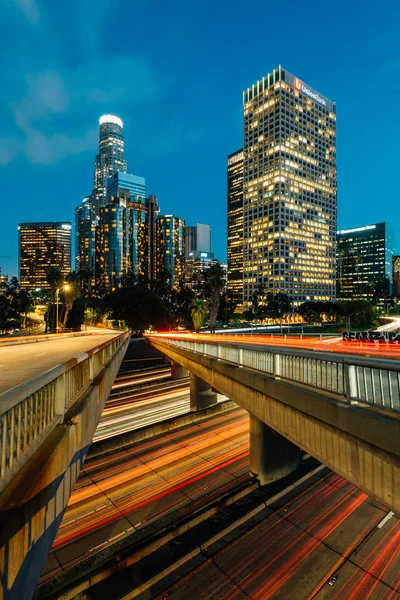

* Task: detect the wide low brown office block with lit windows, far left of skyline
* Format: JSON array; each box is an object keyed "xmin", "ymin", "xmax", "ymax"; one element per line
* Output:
[{"xmin": 18, "ymin": 221, "xmax": 71, "ymax": 289}]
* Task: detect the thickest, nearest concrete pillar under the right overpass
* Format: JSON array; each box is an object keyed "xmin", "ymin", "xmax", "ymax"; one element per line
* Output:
[{"xmin": 250, "ymin": 415, "xmax": 300, "ymax": 485}]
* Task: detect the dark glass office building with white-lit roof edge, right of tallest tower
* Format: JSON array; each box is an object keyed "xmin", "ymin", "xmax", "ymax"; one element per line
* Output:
[{"xmin": 337, "ymin": 223, "xmax": 394, "ymax": 300}]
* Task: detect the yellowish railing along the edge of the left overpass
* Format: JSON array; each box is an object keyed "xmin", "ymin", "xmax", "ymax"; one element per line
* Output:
[{"xmin": 0, "ymin": 333, "xmax": 129, "ymax": 493}]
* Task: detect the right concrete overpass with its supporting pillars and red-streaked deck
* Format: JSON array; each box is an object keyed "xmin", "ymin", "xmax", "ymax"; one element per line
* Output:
[{"xmin": 147, "ymin": 334, "xmax": 400, "ymax": 514}]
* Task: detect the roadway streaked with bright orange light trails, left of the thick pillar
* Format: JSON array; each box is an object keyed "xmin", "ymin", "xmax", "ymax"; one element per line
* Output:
[{"xmin": 42, "ymin": 409, "xmax": 250, "ymax": 581}]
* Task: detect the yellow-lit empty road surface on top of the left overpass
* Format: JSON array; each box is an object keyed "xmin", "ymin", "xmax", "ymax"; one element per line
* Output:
[{"xmin": 0, "ymin": 330, "xmax": 120, "ymax": 394}]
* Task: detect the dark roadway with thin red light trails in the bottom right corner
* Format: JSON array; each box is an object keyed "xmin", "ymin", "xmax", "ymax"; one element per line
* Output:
[{"xmin": 158, "ymin": 474, "xmax": 400, "ymax": 600}]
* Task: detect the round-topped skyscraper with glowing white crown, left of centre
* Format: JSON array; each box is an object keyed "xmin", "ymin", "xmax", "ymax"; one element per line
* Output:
[{"xmin": 92, "ymin": 115, "xmax": 127, "ymax": 215}]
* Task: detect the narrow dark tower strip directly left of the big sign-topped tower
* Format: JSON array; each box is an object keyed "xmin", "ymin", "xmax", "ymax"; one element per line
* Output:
[{"xmin": 227, "ymin": 148, "xmax": 243, "ymax": 306}]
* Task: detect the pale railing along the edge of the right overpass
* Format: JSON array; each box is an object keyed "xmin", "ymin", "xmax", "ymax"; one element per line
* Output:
[{"xmin": 153, "ymin": 335, "xmax": 400, "ymax": 411}]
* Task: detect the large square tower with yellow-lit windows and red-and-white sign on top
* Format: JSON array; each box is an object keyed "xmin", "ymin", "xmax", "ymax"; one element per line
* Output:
[{"xmin": 243, "ymin": 66, "xmax": 337, "ymax": 308}]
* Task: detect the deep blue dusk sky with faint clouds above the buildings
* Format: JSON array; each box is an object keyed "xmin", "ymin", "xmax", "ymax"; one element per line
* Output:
[{"xmin": 0, "ymin": 0, "xmax": 400, "ymax": 275}]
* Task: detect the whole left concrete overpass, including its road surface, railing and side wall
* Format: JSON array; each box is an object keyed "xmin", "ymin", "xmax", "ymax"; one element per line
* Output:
[{"xmin": 0, "ymin": 331, "xmax": 130, "ymax": 600}]
